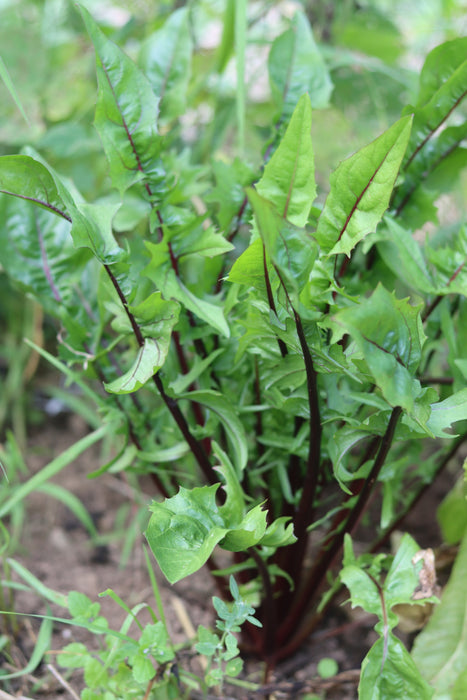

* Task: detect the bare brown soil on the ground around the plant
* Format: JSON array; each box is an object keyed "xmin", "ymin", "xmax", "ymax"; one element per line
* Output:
[{"xmin": 0, "ymin": 416, "xmax": 460, "ymax": 700}]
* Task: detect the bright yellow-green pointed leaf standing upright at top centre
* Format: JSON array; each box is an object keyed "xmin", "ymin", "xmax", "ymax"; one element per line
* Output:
[{"xmin": 256, "ymin": 95, "xmax": 316, "ymax": 227}]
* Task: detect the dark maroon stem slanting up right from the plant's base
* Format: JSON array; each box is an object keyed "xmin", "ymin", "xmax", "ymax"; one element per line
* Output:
[{"xmin": 275, "ymin": 406, "xmax": 402, "ymax": 661}]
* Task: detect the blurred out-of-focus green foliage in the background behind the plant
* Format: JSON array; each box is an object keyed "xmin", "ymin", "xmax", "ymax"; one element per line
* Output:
[{"xmin": 0, "ymin": 0, "xmax": 467, "ymax": 441}]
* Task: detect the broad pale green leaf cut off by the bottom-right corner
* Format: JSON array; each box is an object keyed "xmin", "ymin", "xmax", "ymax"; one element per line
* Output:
[{"xmin": 412, "ymin": 535, "xmax": 467, "ymax": 698}]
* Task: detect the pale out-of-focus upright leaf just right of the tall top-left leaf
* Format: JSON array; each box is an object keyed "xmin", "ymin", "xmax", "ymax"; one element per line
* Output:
[{"xmin": 139, "ymin": 7, "xmax": 193, "ymax": 123}]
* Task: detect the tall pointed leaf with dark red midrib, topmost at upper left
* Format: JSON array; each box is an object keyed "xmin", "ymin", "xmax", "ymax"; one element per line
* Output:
[{"xmin": 80, "ymin": 5, "xmax": 162, "ymax": 194}]
